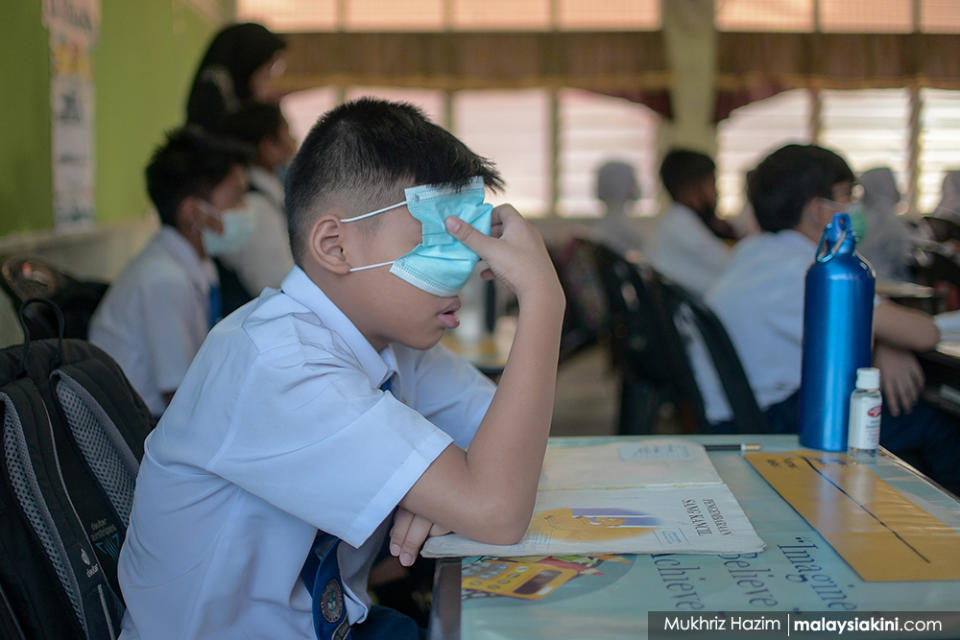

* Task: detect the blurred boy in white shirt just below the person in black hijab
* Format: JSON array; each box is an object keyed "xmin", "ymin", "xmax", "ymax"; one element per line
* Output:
[{"xmin": 218, "ymin": 103, "xmax": 297, "ymax": 314}]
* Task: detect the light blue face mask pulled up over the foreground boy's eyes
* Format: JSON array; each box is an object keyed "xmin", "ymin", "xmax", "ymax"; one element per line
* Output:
[{"xmin": 341, "ymin": 177, "xmax": 493, "ymax": 297}]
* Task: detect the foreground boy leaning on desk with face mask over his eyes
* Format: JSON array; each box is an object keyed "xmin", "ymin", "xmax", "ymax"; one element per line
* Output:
[{"xmin": 119, "ymin": 100, "xmax": 564, "ymax": 640}]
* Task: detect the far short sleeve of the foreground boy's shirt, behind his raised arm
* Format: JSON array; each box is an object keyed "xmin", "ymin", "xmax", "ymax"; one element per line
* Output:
[{"xmin": 404, "ymin": 345, "xmax": 496, "ymax": 449}]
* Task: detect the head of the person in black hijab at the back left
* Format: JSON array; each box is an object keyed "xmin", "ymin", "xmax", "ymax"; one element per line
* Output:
[{"xmin": 187, "ymin": 22, "xmax": 287, "ymax": 132}]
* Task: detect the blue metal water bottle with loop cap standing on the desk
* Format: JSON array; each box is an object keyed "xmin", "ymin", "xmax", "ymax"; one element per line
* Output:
[{"xmin": 799, "ymin": 213, "xmax": 874, "ymax": 451}]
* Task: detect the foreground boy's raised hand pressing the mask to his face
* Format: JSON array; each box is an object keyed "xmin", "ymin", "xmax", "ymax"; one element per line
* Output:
[{"xmin": 446, "ymin": 204, "xmax": 563, "ymax": 301}]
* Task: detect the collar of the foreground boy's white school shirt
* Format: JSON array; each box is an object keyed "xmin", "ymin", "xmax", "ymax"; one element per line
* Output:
[{"xmin": 280, "ymin": 266, "xmax": 397, "ymax": 387}]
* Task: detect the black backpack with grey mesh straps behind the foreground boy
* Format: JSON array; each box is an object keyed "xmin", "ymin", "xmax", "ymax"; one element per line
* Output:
[{"xmin": 0, "ymin": 300, "xmax": 153, "ymax": 640}]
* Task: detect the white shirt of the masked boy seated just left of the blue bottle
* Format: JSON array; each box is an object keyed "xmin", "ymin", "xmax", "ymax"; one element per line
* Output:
[{"xmin": 692, "ymin": 230, "xmax": 817, "ymax": 422}]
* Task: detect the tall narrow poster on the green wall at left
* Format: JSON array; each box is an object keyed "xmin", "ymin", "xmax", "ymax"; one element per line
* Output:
[{"xmin": 43, "ymin": 0, "xmax": 100, "ymax": 230}]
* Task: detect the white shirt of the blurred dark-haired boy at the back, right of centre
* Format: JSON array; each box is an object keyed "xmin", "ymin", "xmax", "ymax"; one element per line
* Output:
[{"xmin": 646, "ymin": 202, "xmax": 731, "ymax": 296}]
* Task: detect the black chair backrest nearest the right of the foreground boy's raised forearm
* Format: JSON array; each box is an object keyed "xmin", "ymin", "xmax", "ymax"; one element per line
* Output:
[{"xmin": 594, "ymin": 245, "xmax": 706, "ymax": 432}]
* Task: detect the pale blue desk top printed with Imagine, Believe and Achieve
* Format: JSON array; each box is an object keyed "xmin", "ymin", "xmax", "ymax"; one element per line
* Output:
[{"xmin": 430, "ymin": 435, "xmax": 960, "ymax": 640}]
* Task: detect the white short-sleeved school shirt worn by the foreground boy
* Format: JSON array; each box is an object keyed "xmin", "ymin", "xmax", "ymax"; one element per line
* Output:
[{"xmin": 119, "ymin": 267, "xmax": 494, "ymax": 640}]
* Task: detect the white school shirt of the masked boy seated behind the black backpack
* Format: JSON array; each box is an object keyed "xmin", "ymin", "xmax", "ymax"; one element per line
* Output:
[{"xmin": 89, "ymin": 226, "xmax": 219, "ymax": 415}]
